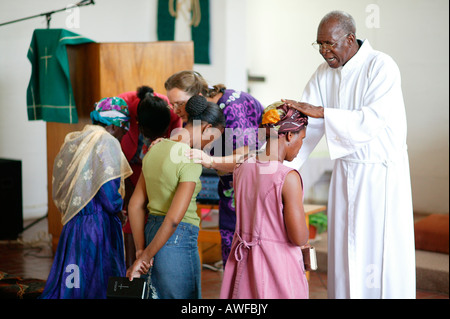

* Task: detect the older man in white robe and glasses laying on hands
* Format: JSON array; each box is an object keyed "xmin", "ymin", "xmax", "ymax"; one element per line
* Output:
[{"xmin": 285, "ymin": 11, "xmax": 416, "ymax": 298}]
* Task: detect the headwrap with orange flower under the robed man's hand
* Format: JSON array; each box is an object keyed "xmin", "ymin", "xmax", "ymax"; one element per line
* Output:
[{"xmin": 261, "ymin": 101, "xmax": 308, "ymax": 136}]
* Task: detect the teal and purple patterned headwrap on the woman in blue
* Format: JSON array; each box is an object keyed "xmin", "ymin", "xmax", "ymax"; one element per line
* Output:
[{"xmin": 91, "ymin": 97, "xmax": 130, "ymax": 131}]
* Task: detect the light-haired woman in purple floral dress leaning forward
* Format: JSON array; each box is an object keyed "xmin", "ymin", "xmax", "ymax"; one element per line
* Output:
[{"xmin": 165, "ymin": 71, "xmax": 264, "ymax": 266}]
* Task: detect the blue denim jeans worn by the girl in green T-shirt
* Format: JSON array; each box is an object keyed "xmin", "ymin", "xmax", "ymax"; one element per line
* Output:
[{"xmin": 145, "ymin": 215, "xmax": 201, "ymax": 299}]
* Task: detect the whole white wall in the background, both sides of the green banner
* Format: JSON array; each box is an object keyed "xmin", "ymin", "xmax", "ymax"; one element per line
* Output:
[{"xmin": 0, "ymin": 0, "xmax": 449, "ymax": 218}]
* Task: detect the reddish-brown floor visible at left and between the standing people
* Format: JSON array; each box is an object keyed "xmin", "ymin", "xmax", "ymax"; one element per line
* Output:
[{"xmin": 0, "ymin": 219, "xmax": 449, "ymax": 299}]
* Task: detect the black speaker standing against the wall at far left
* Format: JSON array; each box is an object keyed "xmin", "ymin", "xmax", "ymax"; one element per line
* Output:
[{"xmin": 0, "ymin": 158, "xmax": 23, "ymax": 240}]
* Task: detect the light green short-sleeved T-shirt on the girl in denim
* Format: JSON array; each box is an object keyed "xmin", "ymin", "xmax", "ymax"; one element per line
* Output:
[{"xmin": 142, "ymin": 140, "xmax": 202, "ymax": 226}]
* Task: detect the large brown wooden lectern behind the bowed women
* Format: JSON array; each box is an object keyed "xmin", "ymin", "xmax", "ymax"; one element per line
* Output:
[{"xmin": 47, "ymin": 41, "xmax": 194, "ymax": 252}]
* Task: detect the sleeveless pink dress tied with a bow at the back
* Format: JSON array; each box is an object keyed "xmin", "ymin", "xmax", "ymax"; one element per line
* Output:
[{"xmin": 220, "ymin": 159, "xmax": 309, "ymax": 299}]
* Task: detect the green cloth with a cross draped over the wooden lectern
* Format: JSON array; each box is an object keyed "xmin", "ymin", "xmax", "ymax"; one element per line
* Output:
[{"xmin": 27, "ymin": 29, "xmax": 94, "ymax": 123}]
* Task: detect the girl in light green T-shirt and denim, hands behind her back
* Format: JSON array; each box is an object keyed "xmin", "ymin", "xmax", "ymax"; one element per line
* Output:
[{"xmin": 127, "ymin": 95, "xmax": 225, "ymax": 299}]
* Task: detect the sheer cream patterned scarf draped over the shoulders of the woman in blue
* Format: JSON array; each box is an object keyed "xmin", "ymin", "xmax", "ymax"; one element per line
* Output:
[{"xmin": 52, "ymin": 125, "xmax": 133, "ymax": 225}]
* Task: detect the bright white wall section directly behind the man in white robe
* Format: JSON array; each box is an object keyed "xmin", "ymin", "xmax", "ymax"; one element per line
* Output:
[{"xmin": 247, "ymin": 0, "xmax": 449, "ymax": 213}]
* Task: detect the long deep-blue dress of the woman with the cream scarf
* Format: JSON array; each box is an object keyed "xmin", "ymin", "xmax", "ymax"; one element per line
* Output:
[{"xmin": 40, "ymin": 178, "xmax": 126, "ymax": 299}]
